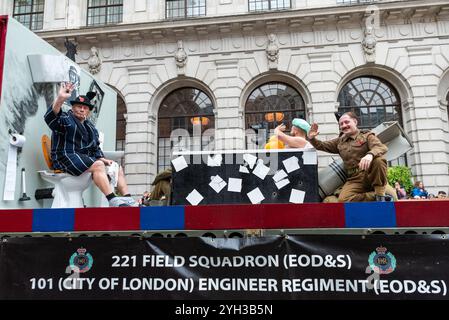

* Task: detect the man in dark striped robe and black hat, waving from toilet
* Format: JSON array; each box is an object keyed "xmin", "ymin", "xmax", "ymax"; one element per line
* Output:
[{"xmin": 44, "ymin": 83, "xmax": 138, "ymax": 207}]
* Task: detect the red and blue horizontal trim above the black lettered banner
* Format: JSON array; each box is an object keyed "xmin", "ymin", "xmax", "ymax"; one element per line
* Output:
[{"xmin": 0, "ymin": 200, "xmax": 449, "ymax": 233}]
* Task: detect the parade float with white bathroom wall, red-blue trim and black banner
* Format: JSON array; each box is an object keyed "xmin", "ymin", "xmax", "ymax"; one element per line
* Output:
[{"xmin": 0, "ymin": 16, "xmax": 449, "ymax": 300}]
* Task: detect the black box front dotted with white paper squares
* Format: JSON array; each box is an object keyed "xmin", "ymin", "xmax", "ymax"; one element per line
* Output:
[{"xmin": 172, "ymin": 149, "xmax": 320, "ymax": 205}]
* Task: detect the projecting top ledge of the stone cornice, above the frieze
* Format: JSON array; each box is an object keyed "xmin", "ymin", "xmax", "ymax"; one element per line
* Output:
[{"xmin": 36, "ymin": 0, "xmax": 449, "ymax": 44}]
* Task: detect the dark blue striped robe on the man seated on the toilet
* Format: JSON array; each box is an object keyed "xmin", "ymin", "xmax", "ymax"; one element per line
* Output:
[{"xmin": 44, "ymin": 106, "xmax": 104, "ymax": 176}]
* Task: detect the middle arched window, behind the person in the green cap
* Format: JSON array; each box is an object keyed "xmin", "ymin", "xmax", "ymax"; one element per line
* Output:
[{"xmin": 245, "ymin": 82, "xmax": 306, "ymax": 149}]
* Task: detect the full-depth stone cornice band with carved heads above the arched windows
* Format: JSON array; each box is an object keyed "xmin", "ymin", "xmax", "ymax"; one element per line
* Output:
[{"xmin": 41, "ymin": 1, "xmax": 449, "ymax": 66}]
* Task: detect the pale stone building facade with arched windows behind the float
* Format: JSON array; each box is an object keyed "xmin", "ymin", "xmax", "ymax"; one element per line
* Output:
[{"xmin": 0, "ymin": 0, "xmax": 449, "ymax": 194}]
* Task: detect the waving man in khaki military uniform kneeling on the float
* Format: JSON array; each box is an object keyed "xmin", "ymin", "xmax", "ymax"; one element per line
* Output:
[{"xmin": 308, "ymin": 112, "xmax": 388, "ymax": 202}]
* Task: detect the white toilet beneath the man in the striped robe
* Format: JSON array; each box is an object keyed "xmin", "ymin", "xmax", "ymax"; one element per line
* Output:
[{"xmin": 38, "ymin": 170, "xmax": 92, "ymax": 208}]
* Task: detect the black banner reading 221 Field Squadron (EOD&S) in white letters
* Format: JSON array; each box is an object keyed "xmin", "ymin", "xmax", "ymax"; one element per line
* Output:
[{"xmin": 0, "ymin": 235, "xmax": 449, "ymax": 300}]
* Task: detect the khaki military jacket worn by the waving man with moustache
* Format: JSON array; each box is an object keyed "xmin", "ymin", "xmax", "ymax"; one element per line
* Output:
[{"xmin": 310, "ymin": 130, "xmax": 388, "ymax": 173}]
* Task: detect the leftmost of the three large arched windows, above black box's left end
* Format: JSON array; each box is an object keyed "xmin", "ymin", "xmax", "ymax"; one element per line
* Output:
[{"xmin": 158, "ymin": 88, "xmax": 215, "ymax": 172}]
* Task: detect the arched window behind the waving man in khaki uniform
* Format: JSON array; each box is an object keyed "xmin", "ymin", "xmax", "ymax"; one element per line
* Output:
[{"xmin": 338, "ymin": 76, "xmax": 406, "ymax": 165}]
